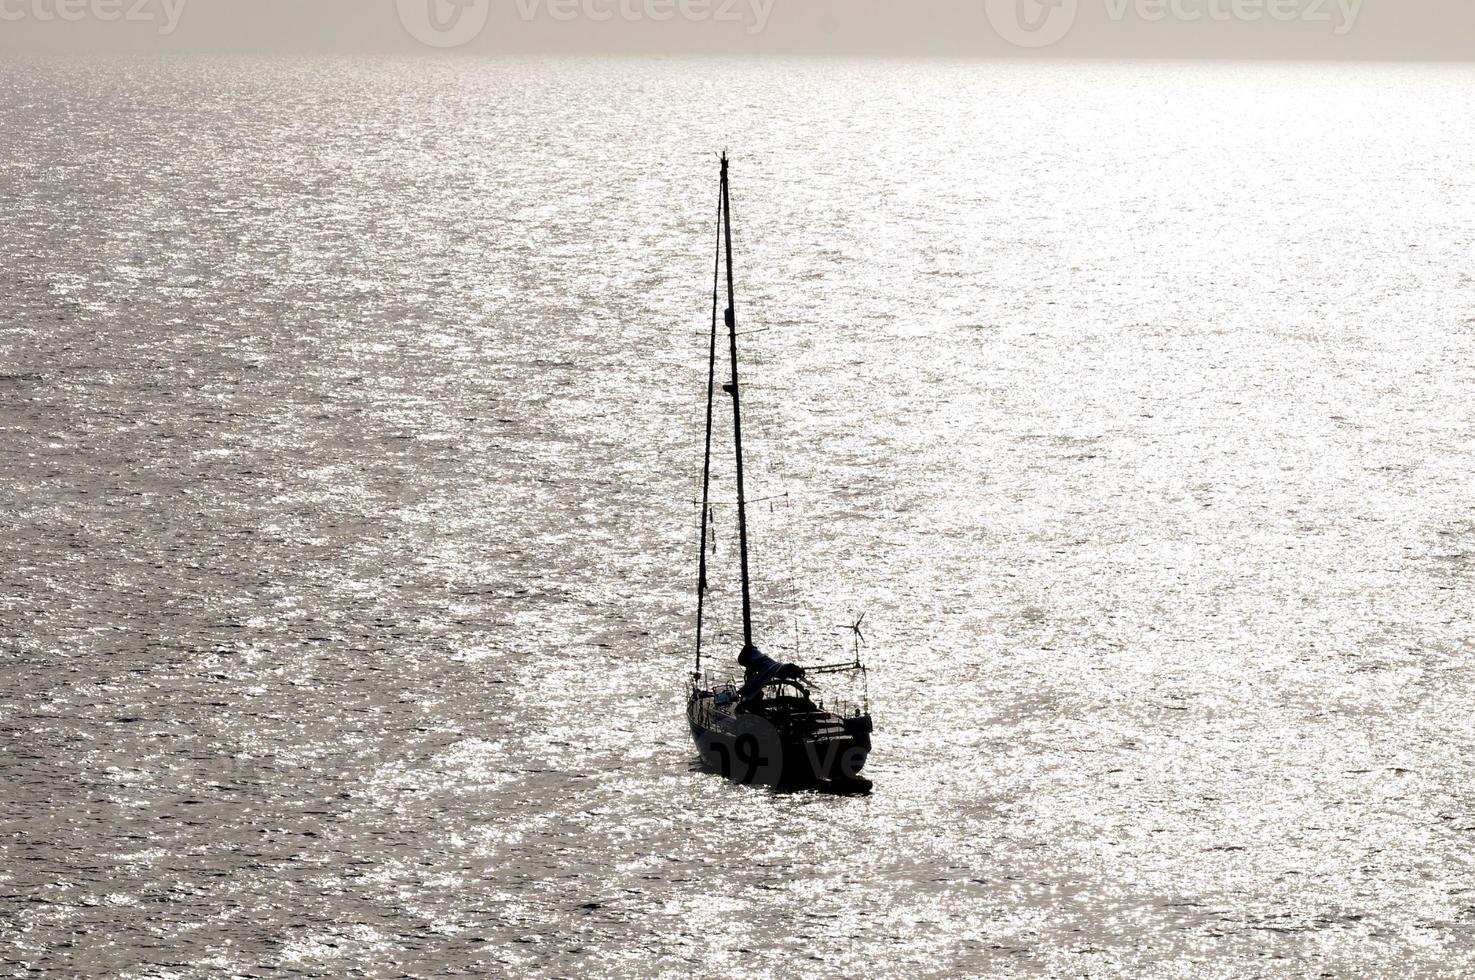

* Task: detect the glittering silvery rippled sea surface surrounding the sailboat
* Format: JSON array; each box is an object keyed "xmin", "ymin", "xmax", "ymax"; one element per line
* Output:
[{"xmin": 0, "ymin": 61, "xmax": 1475, "ymax": 979}]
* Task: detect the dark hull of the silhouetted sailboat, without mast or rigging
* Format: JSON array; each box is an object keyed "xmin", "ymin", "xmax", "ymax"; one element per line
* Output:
[{"xmin": 687, "ymin": 697, "xmax": 872, "ymax": 793}]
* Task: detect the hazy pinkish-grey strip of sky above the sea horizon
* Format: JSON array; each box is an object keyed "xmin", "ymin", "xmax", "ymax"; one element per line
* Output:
[{"xmin": 0, "ymin": 0, "xmax": 1475, "ymax": 61}]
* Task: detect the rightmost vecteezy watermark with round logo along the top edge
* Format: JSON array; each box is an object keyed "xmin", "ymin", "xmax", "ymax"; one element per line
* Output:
[{"xmin": 984, "ymin": 0, "xmax": 1364, "ymax": 47}]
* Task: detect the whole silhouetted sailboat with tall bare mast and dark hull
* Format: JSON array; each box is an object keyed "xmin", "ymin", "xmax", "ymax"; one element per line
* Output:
[{"xmin": 686, "ymin": 153, "xmax": 872, "ymax": 793}]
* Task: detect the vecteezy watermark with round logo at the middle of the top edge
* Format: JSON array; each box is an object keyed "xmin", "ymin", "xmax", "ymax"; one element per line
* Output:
[{"xmin": 398, "ymin": 0, "xmax": 778, "ymax": 47}]
